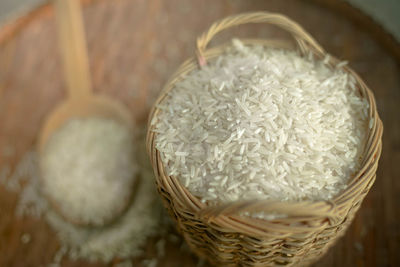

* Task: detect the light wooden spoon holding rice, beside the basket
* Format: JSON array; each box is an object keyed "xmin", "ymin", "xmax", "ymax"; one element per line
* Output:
[{"xmin": 38, "ymin": 0, "xmax": 133, "ymax": 227}]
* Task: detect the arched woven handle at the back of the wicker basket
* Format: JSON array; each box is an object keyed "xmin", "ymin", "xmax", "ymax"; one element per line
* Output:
[{"xmin": 196, "ymin": 12, "xmax": 325, "ymax": 66}]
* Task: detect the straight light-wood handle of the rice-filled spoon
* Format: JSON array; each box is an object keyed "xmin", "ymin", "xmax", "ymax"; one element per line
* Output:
[{"xmin": 55, "ymin": 0, "xmax": 92, "ymax": 101}]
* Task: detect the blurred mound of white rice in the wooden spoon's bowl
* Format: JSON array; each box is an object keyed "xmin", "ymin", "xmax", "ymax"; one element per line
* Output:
[{"xmin": 40, "ymin": 118, "xmax": 137, "ymax": 225}]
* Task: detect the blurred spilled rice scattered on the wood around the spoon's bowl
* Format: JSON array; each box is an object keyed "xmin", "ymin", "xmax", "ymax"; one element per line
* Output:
[{"xmin": 0, "ymin": 126, "xmax": 165, "ymax": 267}]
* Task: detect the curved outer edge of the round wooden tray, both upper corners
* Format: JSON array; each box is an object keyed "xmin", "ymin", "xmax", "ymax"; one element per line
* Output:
[{"xmin": 0, "ymin": 0, "xmax": 400, "ymax": 64}]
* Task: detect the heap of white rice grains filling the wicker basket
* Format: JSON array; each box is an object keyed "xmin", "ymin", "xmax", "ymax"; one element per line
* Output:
[{"xmin": 152, "ymin": 40, "xmax": 371, "ymax": 203}]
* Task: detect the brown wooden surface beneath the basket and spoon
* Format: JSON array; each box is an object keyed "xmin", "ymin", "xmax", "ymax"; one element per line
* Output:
[{"xmin": 0, "ymin": 0, "xmax": 400, "ymax": 267}]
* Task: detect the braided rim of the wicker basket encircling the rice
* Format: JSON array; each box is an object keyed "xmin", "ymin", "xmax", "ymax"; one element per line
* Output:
[{"xmin": 146, "ymin": 11, "xmax": 383, "ymax": 235}]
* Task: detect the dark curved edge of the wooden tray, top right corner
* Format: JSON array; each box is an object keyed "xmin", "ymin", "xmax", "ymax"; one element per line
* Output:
[{"xmin": 303, "ymin": 0, "xmax": 400, "ymax": 64}]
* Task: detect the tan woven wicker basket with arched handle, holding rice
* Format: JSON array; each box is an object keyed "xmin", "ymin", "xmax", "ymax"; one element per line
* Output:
[{"xmin": 146, "ymin": 12, "xmax": 383, "ymax": 266}]
